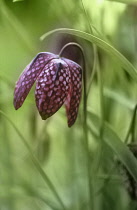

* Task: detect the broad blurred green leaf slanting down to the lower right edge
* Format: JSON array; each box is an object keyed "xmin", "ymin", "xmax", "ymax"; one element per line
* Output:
[{"xmin": 88, "ymin": 111, "xmax": 137, "ymax": 181}]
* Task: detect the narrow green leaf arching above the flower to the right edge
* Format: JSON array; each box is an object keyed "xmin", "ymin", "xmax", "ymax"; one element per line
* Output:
[{"xmin": 40, "ymin": 28, "xmax": 137, "ymax": 81}]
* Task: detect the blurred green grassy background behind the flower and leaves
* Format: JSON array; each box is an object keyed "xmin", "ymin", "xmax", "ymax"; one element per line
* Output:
[{"xmin": 0, "ymin": 0, "xmax": 137, "ymax": 210}]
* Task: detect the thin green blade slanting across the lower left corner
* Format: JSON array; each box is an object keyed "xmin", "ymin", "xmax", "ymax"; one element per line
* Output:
[{"xmin": 0, "ymin": 110, "xmax": 66, "ymax": 210}]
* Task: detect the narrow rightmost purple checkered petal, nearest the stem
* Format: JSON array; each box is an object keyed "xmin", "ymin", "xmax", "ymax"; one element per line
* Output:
[{"xmin": 63, "ymin": 58, "xmax": 82, "ymax": 127}]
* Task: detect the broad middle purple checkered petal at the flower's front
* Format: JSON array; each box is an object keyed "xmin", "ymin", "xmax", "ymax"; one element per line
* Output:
[{"xmin": 35, "ymin": 59, "xmax": 70, "ymax": 120}]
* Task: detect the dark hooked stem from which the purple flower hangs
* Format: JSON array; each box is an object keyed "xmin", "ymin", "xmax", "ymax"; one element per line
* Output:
[{"xmin": 59, "ymin": 42, "xmax": 92, "ymax": 209}]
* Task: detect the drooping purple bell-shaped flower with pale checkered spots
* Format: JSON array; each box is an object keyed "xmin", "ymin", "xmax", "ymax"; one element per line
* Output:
[{"xmin": 14, "ymin": 52, "xmax": 82, "ymax": 127}]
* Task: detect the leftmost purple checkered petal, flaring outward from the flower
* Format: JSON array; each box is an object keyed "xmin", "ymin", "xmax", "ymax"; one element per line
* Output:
[{"xmin": 14, "ymin": 52, "xmax": 57, "ymax": 109}]
